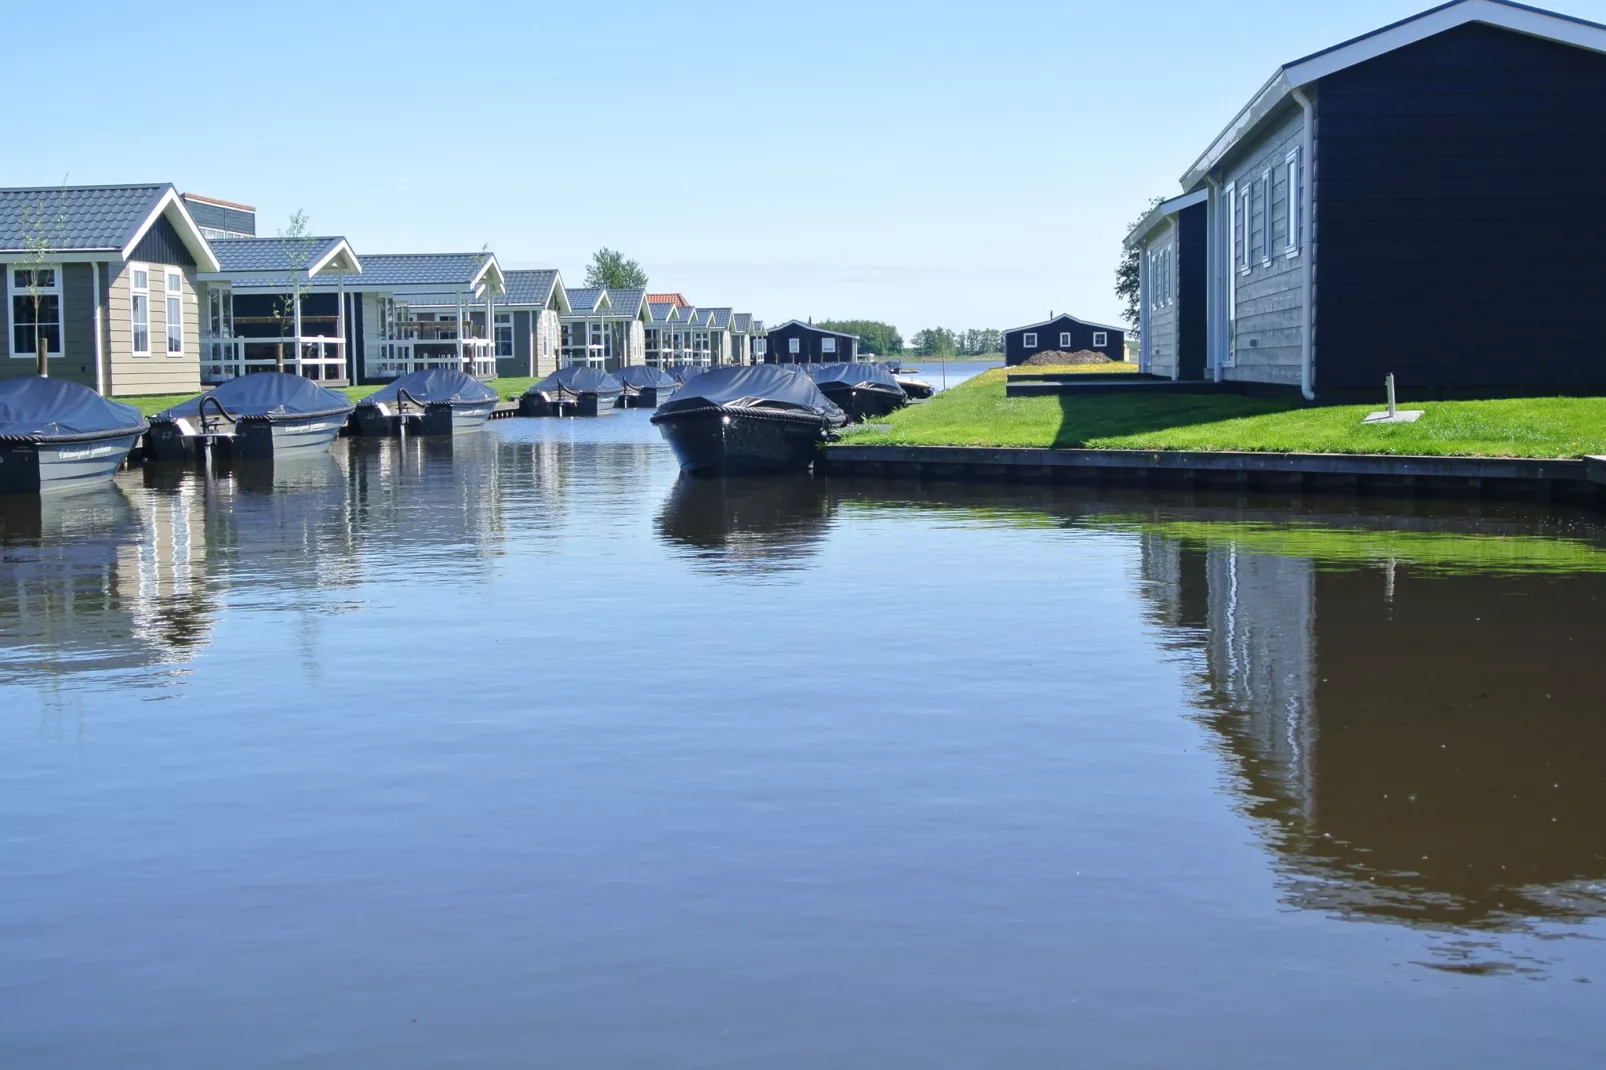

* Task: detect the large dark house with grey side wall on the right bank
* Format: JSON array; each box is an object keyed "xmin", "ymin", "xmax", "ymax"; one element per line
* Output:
[{"xmin": 1127, "ymin": 0, "xmax": 1606, "ymax": 397}]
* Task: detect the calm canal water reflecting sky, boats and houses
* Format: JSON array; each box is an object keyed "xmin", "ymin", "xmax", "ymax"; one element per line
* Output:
[{"xmin": 0, "ymin": 380, "xmax": 1606, "ymax": 1070}]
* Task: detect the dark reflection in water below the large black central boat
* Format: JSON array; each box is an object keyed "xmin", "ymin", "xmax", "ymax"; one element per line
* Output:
[{"xmin": 657, "ymin": 472, "xmax": 834, "ymax": 569}]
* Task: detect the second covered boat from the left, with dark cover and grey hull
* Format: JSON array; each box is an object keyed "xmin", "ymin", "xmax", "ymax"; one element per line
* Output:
[{"xmin": 149, "ymin": 371, "xmax": 357, "ymax": 461}]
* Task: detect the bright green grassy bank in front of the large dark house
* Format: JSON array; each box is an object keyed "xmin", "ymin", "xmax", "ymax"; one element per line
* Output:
[{"xmin": 845, "ymin": 370, "xmax": 1606, "ymax": 458}]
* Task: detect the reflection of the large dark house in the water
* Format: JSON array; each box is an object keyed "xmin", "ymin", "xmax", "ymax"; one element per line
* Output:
[{"xmin": 1142, "ymin": 533, "xmax": 1606, "ymax": 930}]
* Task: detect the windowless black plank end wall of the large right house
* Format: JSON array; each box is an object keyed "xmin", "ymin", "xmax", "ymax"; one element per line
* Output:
[{"xmin": 1315, "ymin": 24, "xmax": 1606, "ymax": 395}]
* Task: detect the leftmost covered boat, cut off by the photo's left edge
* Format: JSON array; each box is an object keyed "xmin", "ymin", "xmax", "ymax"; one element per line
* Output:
[{"xmin": 0, "ymin": 376, "xmax": 149, "ymax": 495}]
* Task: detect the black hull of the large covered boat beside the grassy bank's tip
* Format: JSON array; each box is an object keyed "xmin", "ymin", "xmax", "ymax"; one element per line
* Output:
[{"xmin": 652, "ymin": 406, "xmax": 825, "ymax": 476}]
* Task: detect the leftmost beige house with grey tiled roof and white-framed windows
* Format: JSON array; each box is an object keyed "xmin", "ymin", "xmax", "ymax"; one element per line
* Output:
[{"xmin": 0, "ymin": 185, "xmax": 218, "ymax": 395}]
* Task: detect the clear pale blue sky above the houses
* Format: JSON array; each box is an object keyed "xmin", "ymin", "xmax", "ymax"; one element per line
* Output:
[{"xmin": 9, "ymin": 0, "xmax": 1606, "ymax": 334}]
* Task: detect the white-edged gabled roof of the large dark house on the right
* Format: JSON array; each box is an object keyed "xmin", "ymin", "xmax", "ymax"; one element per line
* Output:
[{"xmin": 1182, "ymin": 0, "xmax": 1606, "ymax": 191}]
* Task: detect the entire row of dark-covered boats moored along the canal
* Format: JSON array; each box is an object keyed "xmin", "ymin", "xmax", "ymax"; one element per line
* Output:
[{"xmin": 0, "ymin": 363, "xmax": 931, "ymax": 493}]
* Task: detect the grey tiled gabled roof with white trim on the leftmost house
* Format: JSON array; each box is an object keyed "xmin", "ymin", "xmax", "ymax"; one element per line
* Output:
[{"xmin": 0, "ymin": 185, "xmax": 218, "ymax": 272}]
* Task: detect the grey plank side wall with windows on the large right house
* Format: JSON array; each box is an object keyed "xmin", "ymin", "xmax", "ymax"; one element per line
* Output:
[{"xmin": 1222, "ymin": 109, "xmax": 1309, "ymax": 384}]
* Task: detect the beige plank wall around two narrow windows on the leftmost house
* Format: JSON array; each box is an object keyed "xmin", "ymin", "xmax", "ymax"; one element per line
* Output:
[{"xmin": 106, "ymin": 263, "xmax": 201, "ymax": 397}]
